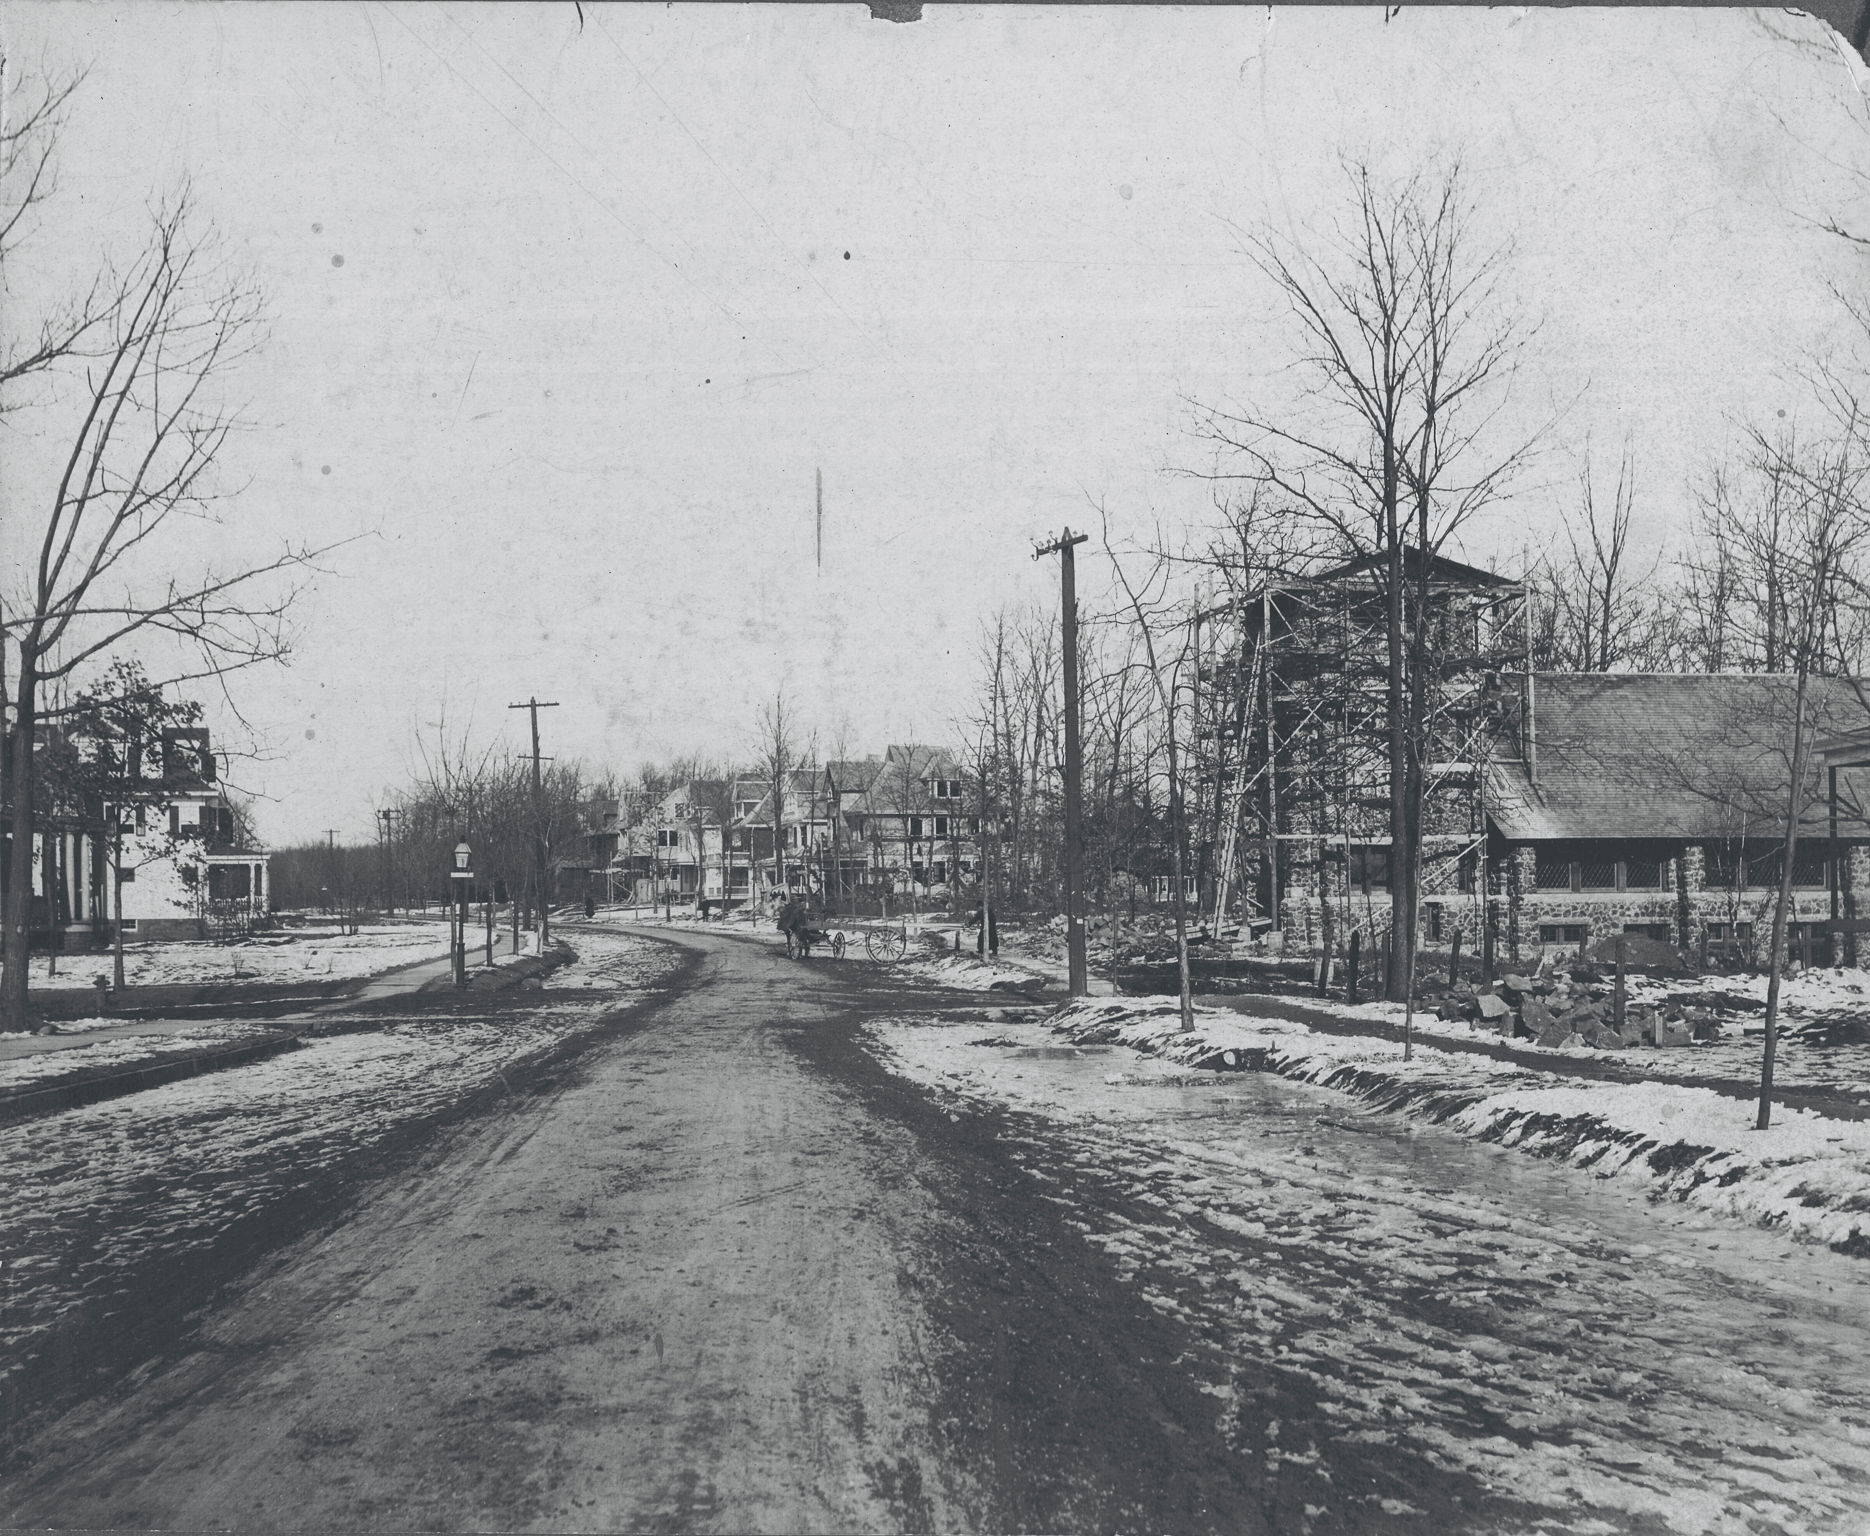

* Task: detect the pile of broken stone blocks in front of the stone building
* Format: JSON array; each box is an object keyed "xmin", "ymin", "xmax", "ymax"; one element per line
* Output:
[{"xmin": 1421, "ymin": 962, "xmax": 1720, "ymax": 1050}]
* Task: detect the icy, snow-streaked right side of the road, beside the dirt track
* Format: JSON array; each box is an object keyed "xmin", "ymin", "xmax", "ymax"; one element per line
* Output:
[{"xmin": 875, "ymin": 1018, "xmax": 1870, "ymax": 1532}]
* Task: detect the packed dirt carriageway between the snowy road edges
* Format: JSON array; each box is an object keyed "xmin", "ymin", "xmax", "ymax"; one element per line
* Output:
[{"xmin": 4, "ymin": 937, "xmax": 1279, "ymax": 1530}]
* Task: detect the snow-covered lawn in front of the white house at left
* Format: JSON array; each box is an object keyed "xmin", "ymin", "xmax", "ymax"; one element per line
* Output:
[{"xmin": 30, "ymin": 922, "xmax": 460, "ymax": 992}]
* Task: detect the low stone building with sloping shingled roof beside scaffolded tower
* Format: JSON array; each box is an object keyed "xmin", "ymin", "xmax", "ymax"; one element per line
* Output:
[{"xmin": 1285, "ymin": 672, "xmax": 1870, "ymax": 964}]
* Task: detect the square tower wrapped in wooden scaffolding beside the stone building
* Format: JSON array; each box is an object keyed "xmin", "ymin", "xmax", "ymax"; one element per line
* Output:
[{"xmin": 1191, "ymin": 548, "xmax": 1526, "ymax": 947}]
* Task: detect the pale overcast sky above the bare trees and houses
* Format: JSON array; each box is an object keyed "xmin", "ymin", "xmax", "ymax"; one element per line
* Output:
[{"xmin": 4, "ymin": 4, "xmax": 1870, "ymax": 842}]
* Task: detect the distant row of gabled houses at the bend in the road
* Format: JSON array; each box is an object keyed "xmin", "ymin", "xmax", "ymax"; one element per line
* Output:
[{"xmin": 559, "ymin": 745, "xmax": 984, "ymax": 913}]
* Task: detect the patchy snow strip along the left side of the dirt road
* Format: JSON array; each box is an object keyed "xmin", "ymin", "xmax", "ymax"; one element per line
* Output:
[{"xmin": 0, "ymin": 934, "xmax": 679, "ymax": 1429}]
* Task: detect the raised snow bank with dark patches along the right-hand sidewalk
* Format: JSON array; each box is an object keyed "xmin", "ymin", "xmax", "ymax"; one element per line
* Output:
[{"xmin": 1053, "ymin": 997, "xmax": 1870, "ymax": 1257}]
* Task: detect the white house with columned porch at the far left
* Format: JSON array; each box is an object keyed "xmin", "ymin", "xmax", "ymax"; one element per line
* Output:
[{"xmin": 0, "ymin": 726, "xmax": 269, "ymax": 950}]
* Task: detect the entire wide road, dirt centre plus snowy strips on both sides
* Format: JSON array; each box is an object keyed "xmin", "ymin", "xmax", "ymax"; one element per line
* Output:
[{"xmin": 0, "ymin": 924, "xmax": 1870, "ymax": 1536}]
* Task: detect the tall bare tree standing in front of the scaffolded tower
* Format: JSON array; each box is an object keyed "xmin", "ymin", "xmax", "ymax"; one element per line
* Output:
[{"xmin": 1201, "ymin": 152, "xmax": 1539, "ymax": 1001}]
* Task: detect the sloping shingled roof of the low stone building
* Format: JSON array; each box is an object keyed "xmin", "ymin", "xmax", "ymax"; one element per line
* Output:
[{"xmin": 1487, "ymin": 672, "xmax": 1870, "ymax": 842}]
